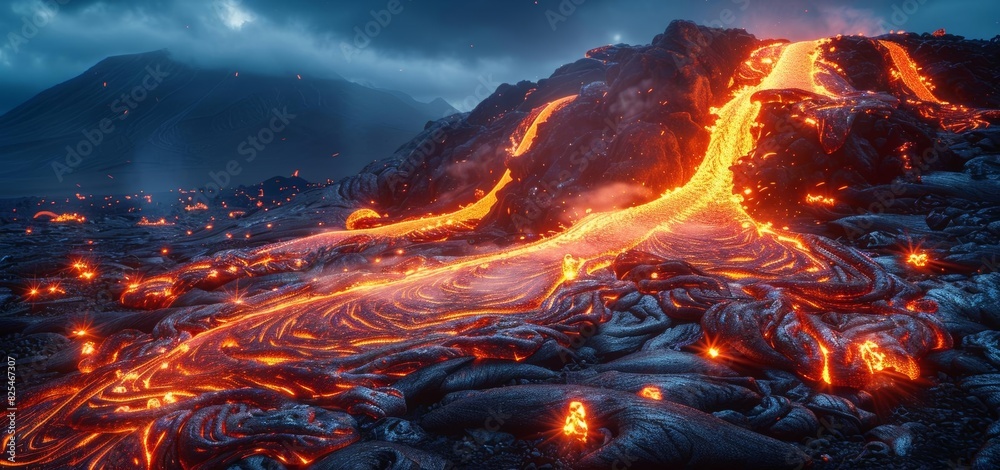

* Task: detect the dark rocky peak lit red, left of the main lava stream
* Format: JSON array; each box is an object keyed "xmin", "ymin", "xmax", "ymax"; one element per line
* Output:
[{"xmin": 362, "ymin": 21, "xmax": 759, "ymax": 233}]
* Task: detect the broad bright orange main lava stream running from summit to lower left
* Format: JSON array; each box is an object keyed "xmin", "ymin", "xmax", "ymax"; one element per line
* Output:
[{"xmin": 5, "ymin": 41, "xmax": 952, "ymax": 467}]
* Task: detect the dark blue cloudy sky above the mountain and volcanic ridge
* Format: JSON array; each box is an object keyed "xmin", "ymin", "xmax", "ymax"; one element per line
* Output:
[{"xmin": 0, "ymin": 0, "xmax": 1000, "ymax": 113}]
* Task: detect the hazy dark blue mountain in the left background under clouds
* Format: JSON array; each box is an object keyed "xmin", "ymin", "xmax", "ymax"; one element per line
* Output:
[{"xmin": 0, "ymin": 51, "xmax": 457, "ymax": 197}]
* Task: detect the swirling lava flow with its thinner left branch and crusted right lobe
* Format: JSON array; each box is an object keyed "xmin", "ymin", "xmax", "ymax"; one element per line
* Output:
[{"xmin": 5, "ymin": 41, "xmax": 950, "ymax": 468}]
